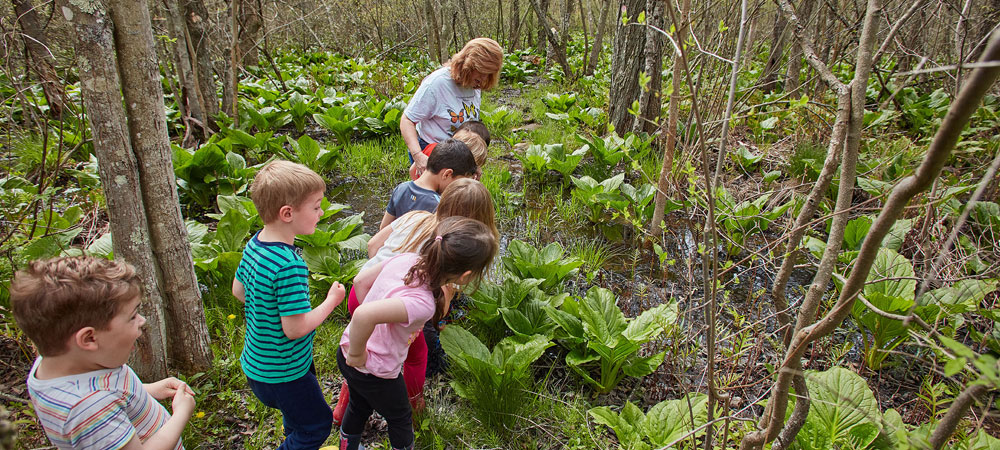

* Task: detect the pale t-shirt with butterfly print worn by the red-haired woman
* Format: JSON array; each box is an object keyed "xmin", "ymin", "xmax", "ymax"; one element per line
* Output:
[{"xmin": 403, "ymin": 66, "xmax": 482, "ymax": 143}]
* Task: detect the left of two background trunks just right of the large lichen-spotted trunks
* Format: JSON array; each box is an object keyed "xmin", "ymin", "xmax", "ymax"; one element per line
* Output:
[{"xmin": 163, "ymin": 0, "xmax": 208, "ymax": 147}]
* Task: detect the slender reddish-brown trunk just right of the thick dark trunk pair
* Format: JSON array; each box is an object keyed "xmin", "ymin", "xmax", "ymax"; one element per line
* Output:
[{"xmin": 649, "ymin": 0, "xmax": 691, "ymax": 236}]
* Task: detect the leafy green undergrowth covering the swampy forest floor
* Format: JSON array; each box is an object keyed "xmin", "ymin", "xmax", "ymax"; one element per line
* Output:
[{"xmin": 0, "ymin": 20, "xmax": 1000, "ymax": 449}]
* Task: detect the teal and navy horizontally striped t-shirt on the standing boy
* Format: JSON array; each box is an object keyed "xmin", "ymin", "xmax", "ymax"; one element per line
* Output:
[{"xmin": 236, "ymin": 234, "xmax": 316, "ymax": 383}]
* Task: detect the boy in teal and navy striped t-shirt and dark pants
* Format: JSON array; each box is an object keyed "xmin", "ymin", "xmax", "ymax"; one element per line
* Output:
[{"xmin": 233, "ymin": 160, "xmax": 344, "ymax": 450}]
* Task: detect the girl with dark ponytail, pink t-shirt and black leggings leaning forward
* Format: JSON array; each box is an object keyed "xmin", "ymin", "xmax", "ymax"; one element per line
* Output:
[{"xmin": 337, "ymin": 217, "xmax": 499, "ymax": 450}]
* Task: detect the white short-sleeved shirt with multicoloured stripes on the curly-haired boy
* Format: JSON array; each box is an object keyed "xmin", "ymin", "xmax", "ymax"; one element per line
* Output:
[{"xmin": 28, "ymin": 356, "xmax": 184, "ymax": 450}]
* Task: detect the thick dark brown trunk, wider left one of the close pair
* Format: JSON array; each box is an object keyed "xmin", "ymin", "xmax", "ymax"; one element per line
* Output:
[{"xmin": 608, "ymin": 0, "xmax": 646, "ymax": 134}]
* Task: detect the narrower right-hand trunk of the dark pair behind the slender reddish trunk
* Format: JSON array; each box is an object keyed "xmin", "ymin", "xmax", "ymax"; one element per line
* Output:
[{"xmin": 632, "ymin": 0, "xmax": 664, "ymax": 133}]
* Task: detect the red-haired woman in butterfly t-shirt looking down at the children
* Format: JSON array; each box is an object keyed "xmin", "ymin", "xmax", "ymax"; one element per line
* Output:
[{"xmin": 399, "ymin": 38, "xmax": 503, "ymax": 176}]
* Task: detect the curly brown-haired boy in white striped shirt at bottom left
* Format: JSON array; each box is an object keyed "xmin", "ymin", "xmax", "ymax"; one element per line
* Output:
[{"xmin": 10, "ymin": 257, "xmax": 194, "ymax": 449}]
